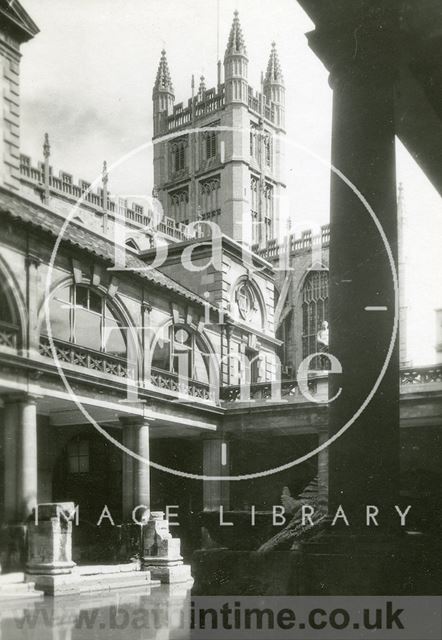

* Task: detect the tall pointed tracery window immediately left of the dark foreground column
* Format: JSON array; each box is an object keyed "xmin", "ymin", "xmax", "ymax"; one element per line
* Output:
[{"xmin": 302, "ymin": 270, "xmax": 328, "ymax": 369}]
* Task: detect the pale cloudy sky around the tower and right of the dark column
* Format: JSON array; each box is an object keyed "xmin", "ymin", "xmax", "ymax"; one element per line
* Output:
[{"xmin": 21, "ymin": 0, "xmax": 442, "ymax": 365}]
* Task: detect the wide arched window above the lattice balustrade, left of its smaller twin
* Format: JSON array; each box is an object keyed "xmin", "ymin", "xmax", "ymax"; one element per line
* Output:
[{"xmin": 50, "ymin": 285, "xmax": 127, "ymax": 357}]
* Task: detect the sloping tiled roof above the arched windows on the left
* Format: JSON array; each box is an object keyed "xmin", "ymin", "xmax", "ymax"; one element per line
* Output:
[{"xmin": 0, "ymin": 190, "xmax": 214, "ymax": 304}]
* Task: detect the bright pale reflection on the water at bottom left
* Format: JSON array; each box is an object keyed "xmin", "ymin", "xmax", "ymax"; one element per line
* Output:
[{"xmin": 0, "ymin": 584, "xmax": 190, "ymax": 640}]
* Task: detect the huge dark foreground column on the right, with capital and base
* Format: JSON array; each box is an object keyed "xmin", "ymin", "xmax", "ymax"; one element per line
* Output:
[{"xmin": 297, "ymin": 7, "xmax": 403, "ymax": 595}]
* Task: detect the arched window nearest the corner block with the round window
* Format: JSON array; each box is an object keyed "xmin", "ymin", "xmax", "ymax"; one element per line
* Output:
[{"xmin": 152, "ymin": 325, "xmax": 210, "ymax": 384}]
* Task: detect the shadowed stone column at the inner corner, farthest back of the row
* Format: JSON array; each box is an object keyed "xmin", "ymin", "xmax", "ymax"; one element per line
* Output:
[{"xmin": 203, "ymin": 436, "xmax": 230, "ymax": 511}]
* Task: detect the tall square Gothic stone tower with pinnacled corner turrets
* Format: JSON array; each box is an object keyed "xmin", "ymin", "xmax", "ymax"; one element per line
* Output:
[{"xmin": 153, "ymin": 11, "xmax": 285, "ymax": 246}]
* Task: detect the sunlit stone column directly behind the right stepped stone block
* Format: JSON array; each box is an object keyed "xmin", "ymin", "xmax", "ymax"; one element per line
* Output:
[{"xmin": 120, "ymin": 417, "xmax": 150, "ymax": 521}]
